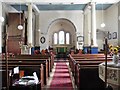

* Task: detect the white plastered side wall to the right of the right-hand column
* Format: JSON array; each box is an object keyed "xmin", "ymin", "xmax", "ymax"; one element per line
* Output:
[{"xmin": 105, "ymin": 4, "xmax": 118, "ymax": 46}]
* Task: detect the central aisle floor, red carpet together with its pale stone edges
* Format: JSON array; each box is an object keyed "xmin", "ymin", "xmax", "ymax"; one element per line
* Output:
[{"xmin": 43, "ymin": 59, "xmax": 75, "ymax": 90}]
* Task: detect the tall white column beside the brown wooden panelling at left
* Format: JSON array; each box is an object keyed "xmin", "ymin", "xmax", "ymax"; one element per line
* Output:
[{"xmin": 27, "ymin": 3, "xmax": 33, "ymax": 54}]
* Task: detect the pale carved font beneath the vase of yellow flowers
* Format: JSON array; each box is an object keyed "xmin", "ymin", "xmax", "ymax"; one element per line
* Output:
[{"xmin": 99, "ymin": 62, "xmax": 120, "ymax": 90}]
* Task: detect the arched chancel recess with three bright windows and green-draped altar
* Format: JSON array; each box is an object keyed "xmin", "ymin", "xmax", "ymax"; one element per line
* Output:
[{"xmin": 48, "ymin": 18, "xmax": 76, "ymax": 57}]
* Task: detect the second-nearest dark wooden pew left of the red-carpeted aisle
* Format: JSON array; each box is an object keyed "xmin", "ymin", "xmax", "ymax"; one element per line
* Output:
[{"xmin": 2, "ymin": 58, "xmax": 49, "ymax": 85}]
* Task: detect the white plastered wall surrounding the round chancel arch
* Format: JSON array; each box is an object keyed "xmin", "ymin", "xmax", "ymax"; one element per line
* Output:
[{"xmin": 36, "ymin": 11, "xmax": 83, "ymax": 49}]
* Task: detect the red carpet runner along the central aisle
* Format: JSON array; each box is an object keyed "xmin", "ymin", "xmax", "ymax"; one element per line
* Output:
[{"xmin": 50, "ymin": 62, "xmax": 73, "ymax": 90}]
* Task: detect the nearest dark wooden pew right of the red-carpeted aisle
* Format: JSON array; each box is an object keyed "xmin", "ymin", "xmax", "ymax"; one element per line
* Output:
[{"xmin": 75, "ymin": 63, "xmax": 105, "ymax": 90}]
